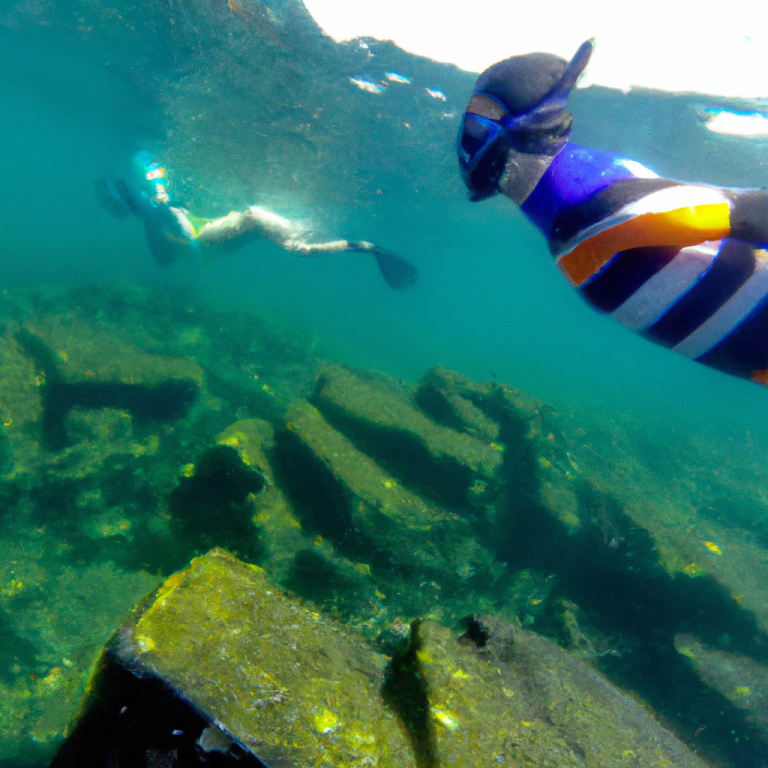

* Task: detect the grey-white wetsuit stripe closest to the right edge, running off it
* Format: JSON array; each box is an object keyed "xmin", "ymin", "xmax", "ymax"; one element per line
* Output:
[{"xmin": 672, "ymin": 251, "xmax": 768, "ymax": 359}]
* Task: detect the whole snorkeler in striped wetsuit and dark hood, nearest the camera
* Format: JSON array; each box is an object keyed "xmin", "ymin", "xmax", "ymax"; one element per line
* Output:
[{"xmin": 458, "ymin": 40, "xmax": 768, "ymax": 385}]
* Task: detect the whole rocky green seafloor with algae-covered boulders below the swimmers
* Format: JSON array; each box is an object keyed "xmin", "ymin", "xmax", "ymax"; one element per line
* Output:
[{"xmin": 0, "ymin": 287, "xmax": 768, "ymax": 768}]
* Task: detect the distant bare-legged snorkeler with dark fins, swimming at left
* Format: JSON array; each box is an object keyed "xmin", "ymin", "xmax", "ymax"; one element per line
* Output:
[{"xmin": 96, "ymin": 152, "xmax": 418, "ymax": 289}]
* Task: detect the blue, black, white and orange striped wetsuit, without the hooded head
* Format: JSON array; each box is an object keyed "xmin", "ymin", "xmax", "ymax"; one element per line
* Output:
[{"xmin": 522, "ymin": 143, "xmax": 768, "ymax": 384}]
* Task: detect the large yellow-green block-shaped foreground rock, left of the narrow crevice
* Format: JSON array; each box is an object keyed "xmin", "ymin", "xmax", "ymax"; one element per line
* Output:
[{"xmin": 116, "ymin": 550, "xmax": 415, "ymax": 768}]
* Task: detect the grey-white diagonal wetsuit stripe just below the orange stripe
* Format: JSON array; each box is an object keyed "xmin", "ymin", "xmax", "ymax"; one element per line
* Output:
[{"xmin": 611, "ymin": 240, "xmax": 722, "ymax": 331}]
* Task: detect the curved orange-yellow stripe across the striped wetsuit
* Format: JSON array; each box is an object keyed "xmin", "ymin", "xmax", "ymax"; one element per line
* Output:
[{"xmin": 557, "ymin": 201, "xmax": 731, "ymax": 286}]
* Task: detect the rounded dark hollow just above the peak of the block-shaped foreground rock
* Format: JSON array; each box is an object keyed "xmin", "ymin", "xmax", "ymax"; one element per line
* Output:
[{"xmin": 168, "ymin": 446, "xmax": 265, "ymax": 565}]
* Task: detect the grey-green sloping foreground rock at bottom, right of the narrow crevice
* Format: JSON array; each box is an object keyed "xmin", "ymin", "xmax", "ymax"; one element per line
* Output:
[{"xmin": 393, "ymin": 619, "xmax": 704, "ymax": 768}]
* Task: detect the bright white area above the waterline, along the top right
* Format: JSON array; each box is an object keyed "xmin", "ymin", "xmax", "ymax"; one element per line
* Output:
[{"xmin": 305, "ymin": 0, "xmax": 768, "ymax": 98}]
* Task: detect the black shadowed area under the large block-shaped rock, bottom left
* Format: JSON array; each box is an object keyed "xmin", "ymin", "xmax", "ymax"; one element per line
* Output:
[{"xmin": 50, "ymin": 658, "xmax": 267, "ymax": 768}]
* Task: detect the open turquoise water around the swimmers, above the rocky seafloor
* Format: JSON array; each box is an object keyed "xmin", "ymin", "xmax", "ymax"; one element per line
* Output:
[{"xmin": 0, "ymin": 0, "xmax": 768, "ymax": 766}]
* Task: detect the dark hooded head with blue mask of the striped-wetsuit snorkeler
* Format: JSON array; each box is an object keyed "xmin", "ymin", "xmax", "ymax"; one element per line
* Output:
[{"xmin": 458, "ymin": 40, "xmax": 594, "ymax": 201}]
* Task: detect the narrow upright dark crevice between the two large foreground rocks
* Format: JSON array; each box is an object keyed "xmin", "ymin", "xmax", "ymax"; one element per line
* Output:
[{"xmin": 382, "ymin": 621, "xmax": 441, "ymax": 768}]
